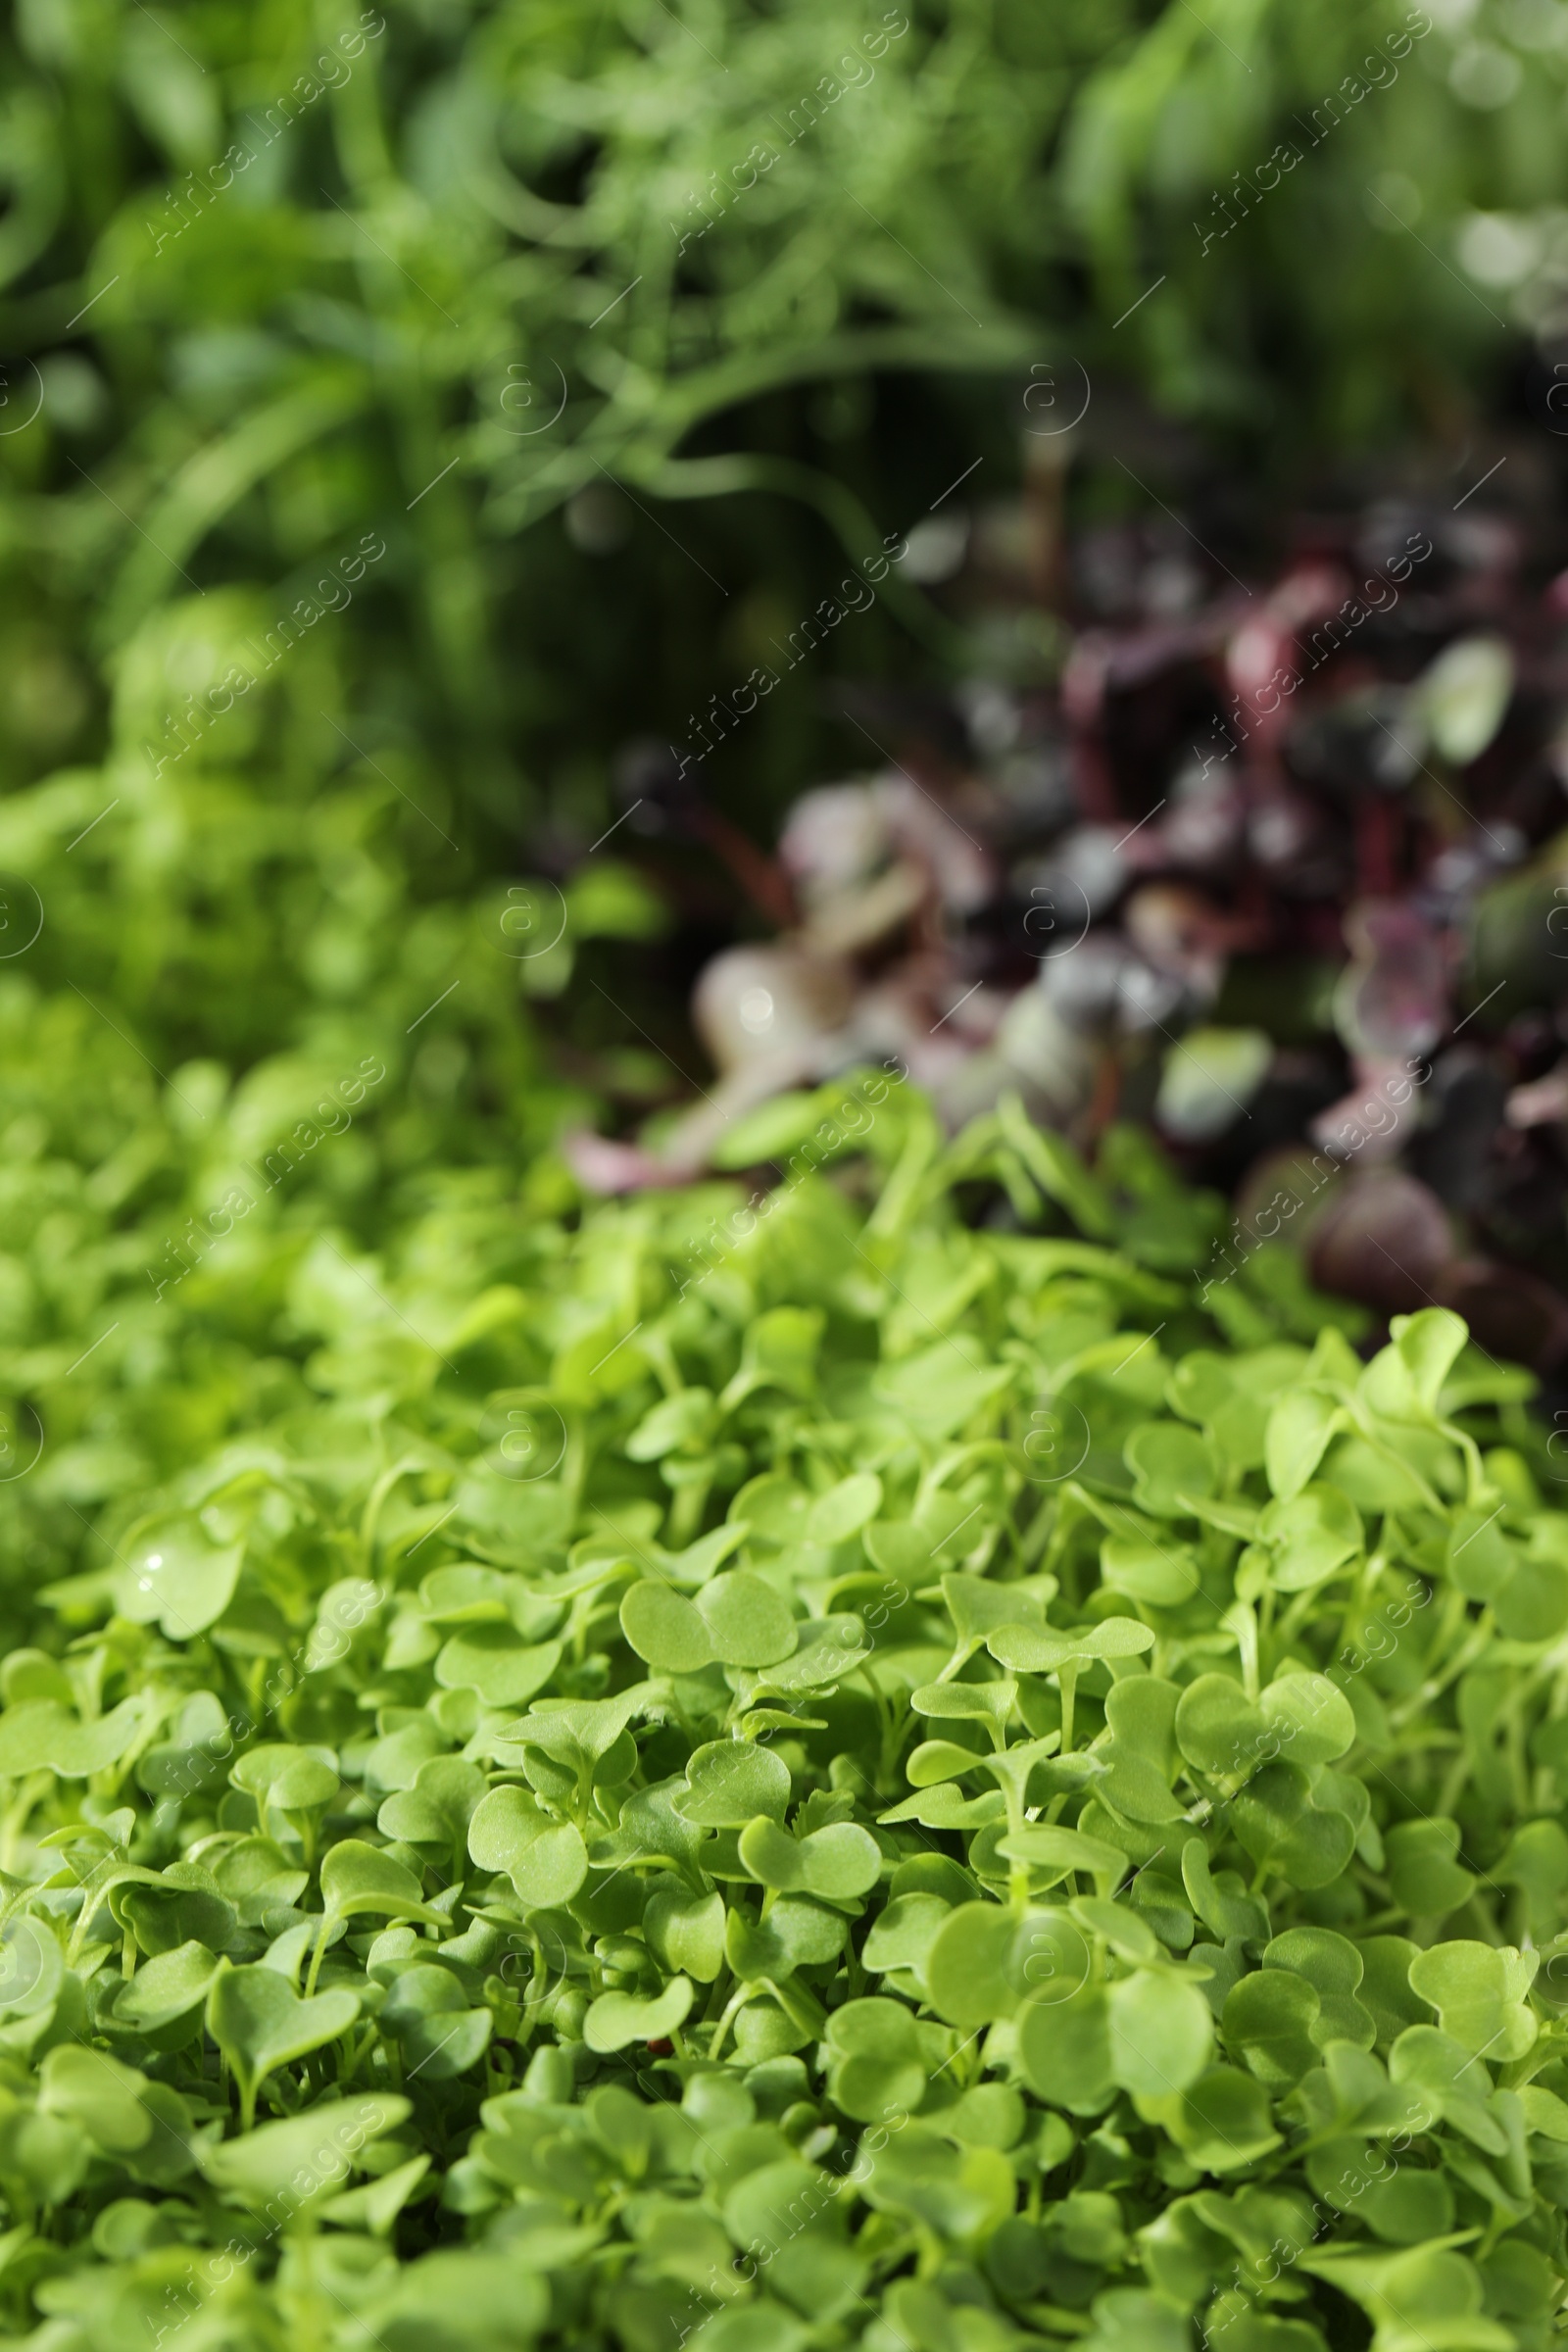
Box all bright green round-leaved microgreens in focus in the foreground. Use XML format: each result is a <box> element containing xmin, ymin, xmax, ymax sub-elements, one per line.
<box><xmin>0</xmin><ymin>1080</ymin><xmax>1568</xmax><ymax>2352</ymax></box>
